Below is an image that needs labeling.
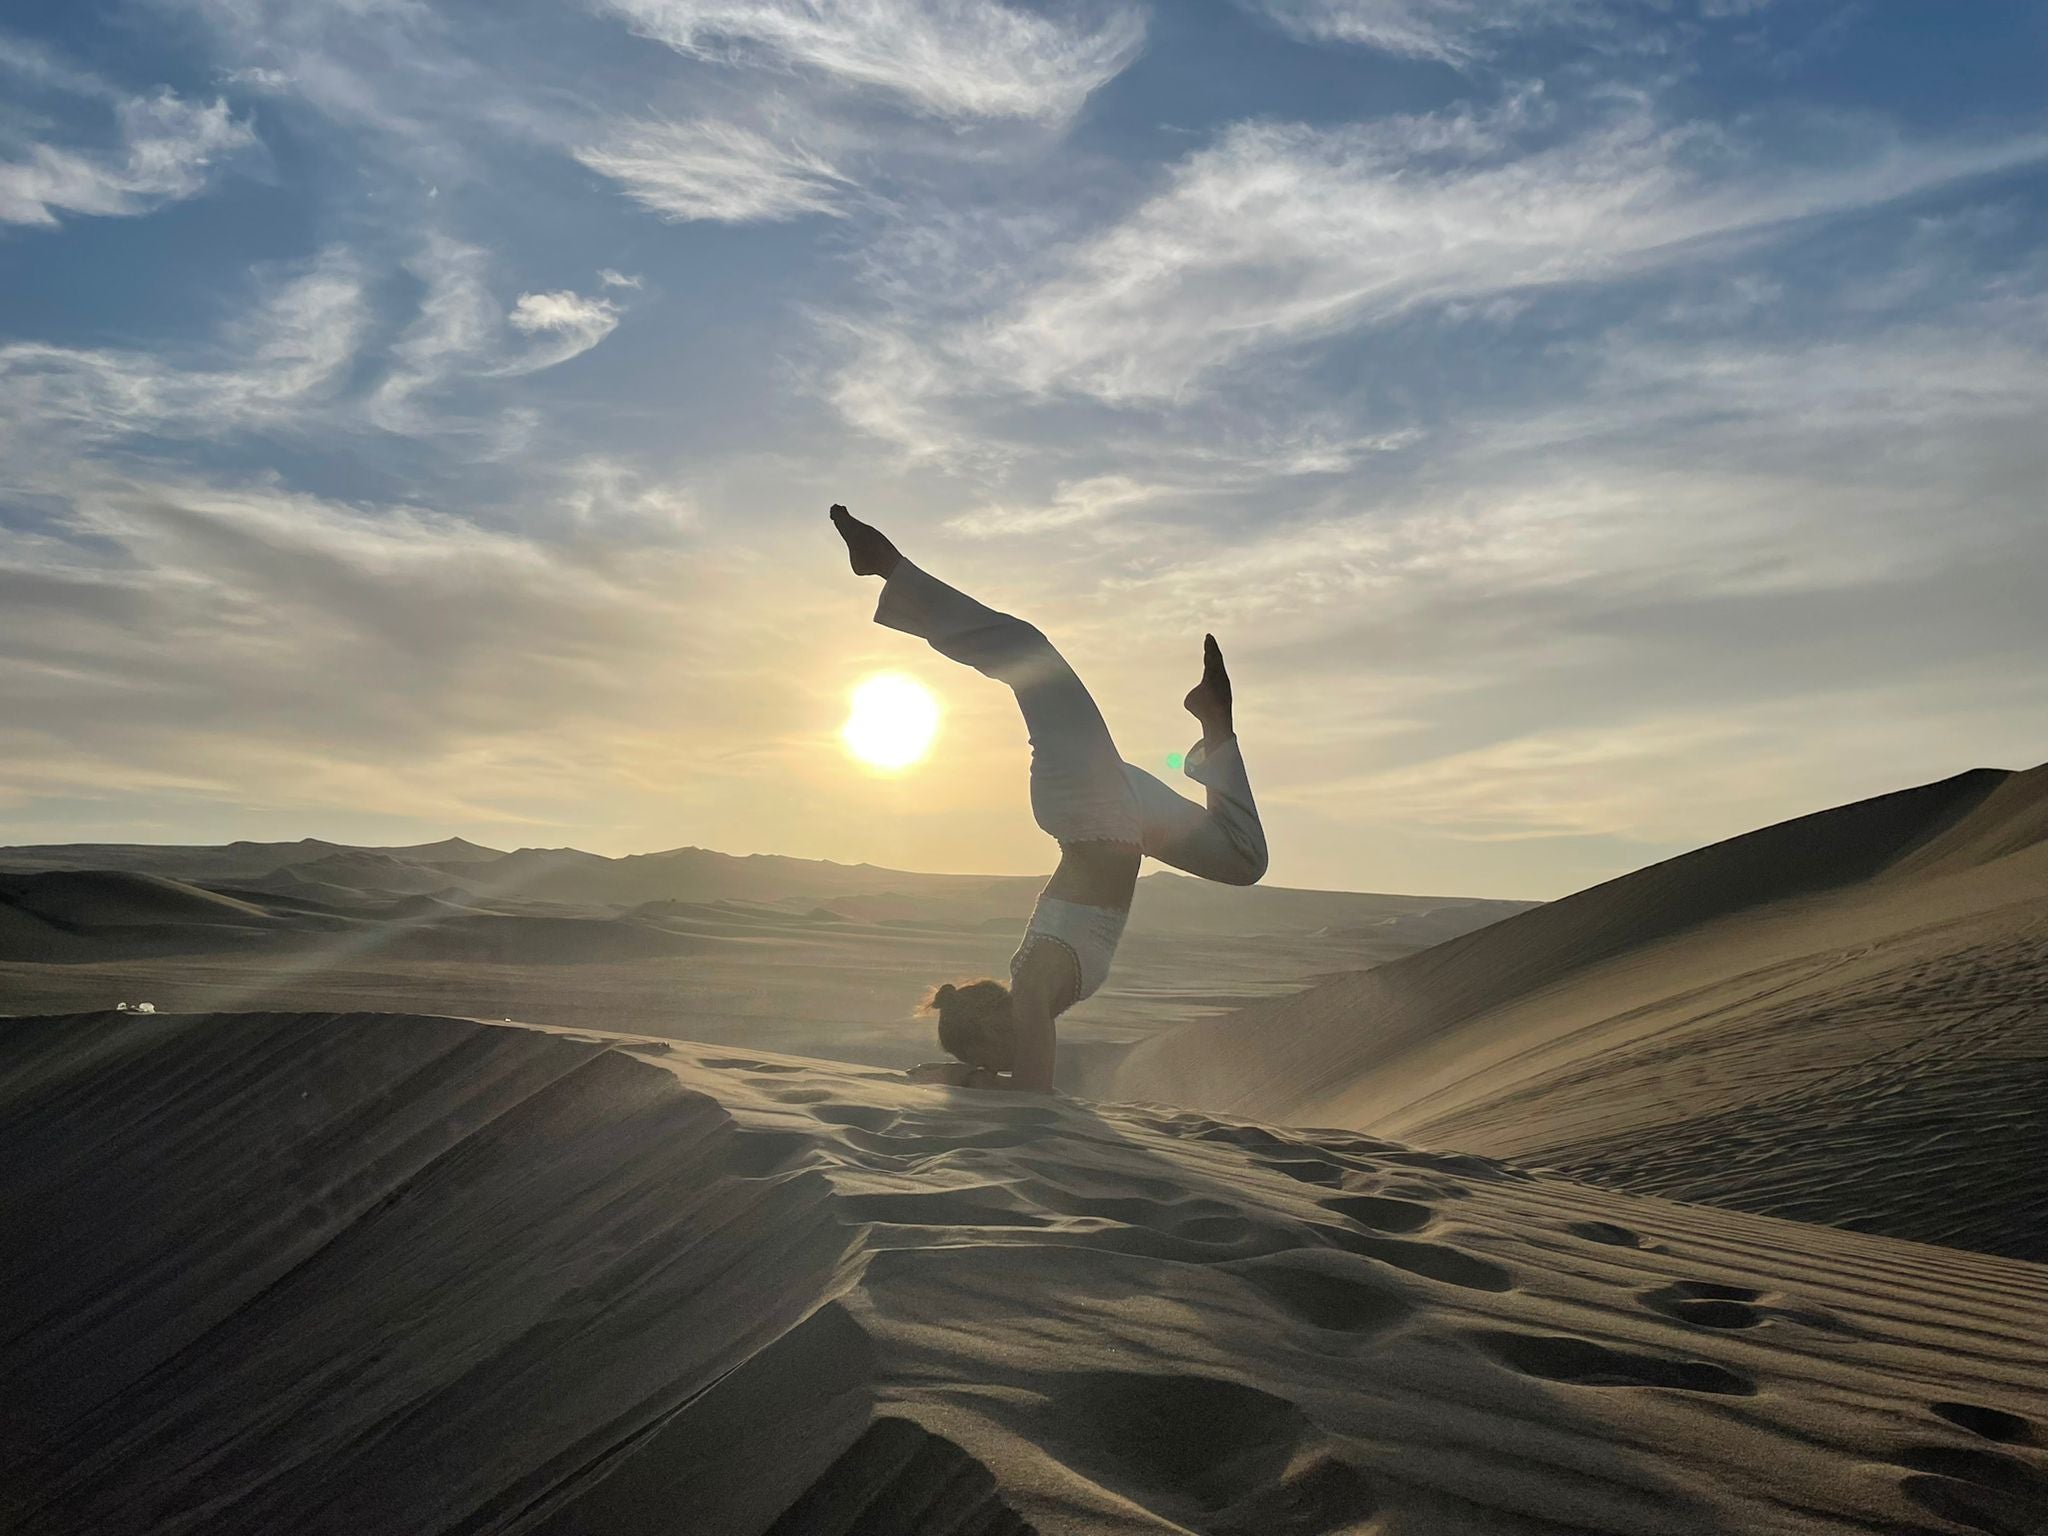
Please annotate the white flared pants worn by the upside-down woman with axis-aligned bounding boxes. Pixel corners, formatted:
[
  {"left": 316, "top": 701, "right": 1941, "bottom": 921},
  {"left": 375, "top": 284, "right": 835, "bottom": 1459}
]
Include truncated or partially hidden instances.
[{"left": 874, "top": 559, "right": 1266, "bottom": 885}]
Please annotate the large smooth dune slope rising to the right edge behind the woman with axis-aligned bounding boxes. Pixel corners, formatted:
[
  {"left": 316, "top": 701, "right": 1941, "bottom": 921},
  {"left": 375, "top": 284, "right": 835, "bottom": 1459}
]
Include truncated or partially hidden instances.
[{"left": 1092, "top": 768, "right": 2048, "bottom": 1260}]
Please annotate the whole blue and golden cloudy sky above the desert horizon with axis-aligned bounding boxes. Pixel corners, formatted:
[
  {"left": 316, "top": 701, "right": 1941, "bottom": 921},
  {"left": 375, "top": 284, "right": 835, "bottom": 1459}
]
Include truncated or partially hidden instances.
[{"left": 0, "top": 0, "right": 2048, "bottom": 897}]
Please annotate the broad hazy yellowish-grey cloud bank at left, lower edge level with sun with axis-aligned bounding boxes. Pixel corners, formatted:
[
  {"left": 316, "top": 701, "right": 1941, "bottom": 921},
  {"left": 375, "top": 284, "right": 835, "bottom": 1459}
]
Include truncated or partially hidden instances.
[{"left": 0, "top": 465, "right": 696, "bottom": 799}]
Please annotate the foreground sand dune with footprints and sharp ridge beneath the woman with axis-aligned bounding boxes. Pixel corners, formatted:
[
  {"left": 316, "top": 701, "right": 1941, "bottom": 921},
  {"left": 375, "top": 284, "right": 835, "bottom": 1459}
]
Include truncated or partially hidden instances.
[{"left": 0, "top": 1016, "right": 2048, "bottom": 1536}]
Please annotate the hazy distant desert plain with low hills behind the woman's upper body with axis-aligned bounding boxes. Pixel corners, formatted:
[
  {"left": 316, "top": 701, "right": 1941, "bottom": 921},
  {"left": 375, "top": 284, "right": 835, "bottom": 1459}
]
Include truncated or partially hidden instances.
[{"left": 0, "top": 838, "right": 1526, "bottom": 1081}]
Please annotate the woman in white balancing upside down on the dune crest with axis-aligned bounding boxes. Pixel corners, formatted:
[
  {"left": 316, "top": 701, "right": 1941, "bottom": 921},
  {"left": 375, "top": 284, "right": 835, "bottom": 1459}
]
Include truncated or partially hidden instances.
[{"left": 831, "top": 506, "right": 1266, "bottom": 1094}]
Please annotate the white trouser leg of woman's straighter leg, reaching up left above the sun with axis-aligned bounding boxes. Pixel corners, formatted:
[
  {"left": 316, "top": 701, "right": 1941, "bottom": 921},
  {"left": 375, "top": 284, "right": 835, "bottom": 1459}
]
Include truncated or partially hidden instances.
[{"left": 874, "top": 559, "right": 1141, "bottom": 848}]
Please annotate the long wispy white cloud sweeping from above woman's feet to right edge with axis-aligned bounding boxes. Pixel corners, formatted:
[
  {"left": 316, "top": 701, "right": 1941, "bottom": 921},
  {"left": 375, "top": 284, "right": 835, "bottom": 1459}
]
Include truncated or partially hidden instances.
[{"left": 836, "top": 96, "right": 2048, "bottom": 453}]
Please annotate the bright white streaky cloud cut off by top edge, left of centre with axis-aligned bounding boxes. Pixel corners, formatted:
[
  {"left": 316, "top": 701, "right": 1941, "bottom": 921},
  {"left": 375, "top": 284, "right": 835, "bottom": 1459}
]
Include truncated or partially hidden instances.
[{"left": 602, "top": 0, "right": 1145, "bottom": 121}]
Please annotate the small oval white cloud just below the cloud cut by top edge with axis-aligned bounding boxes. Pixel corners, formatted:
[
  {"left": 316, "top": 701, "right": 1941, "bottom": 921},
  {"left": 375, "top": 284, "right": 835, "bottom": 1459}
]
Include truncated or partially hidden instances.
[{"left": 575, "top": 121, "right": 848, "bottom": 223}]
